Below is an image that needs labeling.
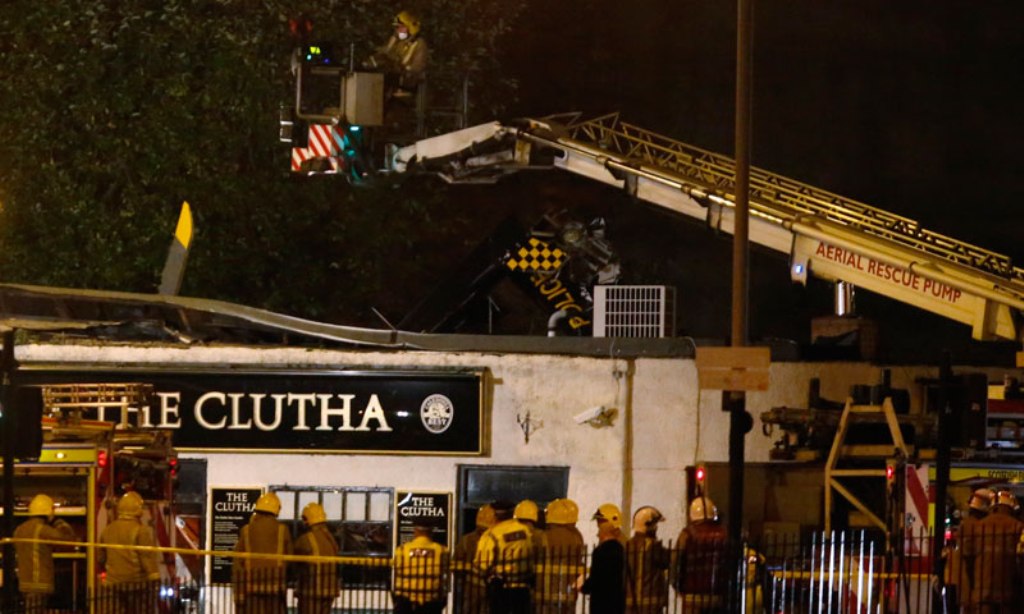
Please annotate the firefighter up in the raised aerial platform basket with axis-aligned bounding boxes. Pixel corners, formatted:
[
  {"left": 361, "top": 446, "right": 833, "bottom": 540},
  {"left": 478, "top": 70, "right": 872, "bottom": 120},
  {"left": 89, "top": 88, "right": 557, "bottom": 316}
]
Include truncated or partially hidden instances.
[{"left": 367, "top": 10, "right": 427, "bottom": 98}]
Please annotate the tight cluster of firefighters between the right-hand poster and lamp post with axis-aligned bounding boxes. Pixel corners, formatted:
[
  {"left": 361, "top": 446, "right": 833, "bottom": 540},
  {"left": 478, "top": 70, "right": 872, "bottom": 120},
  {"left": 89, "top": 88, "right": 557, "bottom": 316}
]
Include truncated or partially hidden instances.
[{"left": 454, "top": 497, "right": 741, "bottom": 614}]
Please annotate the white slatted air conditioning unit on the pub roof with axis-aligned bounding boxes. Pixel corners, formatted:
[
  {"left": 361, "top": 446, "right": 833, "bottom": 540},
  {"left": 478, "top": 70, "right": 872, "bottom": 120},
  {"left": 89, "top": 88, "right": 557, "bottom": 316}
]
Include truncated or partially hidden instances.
[{"left": 594, "top": 286, "right": 676, "bottom": 338}]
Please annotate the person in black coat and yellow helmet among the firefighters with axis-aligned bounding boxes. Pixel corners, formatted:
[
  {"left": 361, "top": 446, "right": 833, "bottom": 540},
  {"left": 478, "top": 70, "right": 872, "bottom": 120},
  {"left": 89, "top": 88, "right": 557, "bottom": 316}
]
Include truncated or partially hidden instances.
[{"left": 577, "top": 503, "right": 626, "bottom": 614}]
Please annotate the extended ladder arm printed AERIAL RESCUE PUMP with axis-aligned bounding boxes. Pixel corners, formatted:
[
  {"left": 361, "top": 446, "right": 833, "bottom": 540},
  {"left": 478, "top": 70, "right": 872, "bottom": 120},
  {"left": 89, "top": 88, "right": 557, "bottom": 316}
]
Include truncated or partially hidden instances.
[{"left": 389, "top": 114, "right": 1024, "bottom": 365}]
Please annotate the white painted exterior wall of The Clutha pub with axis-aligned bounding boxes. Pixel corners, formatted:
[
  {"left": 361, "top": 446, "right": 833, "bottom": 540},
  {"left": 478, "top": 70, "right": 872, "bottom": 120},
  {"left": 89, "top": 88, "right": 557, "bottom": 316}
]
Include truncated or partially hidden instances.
[{"left": 15, "top": 345, "right": 1021, "bottom": 541}]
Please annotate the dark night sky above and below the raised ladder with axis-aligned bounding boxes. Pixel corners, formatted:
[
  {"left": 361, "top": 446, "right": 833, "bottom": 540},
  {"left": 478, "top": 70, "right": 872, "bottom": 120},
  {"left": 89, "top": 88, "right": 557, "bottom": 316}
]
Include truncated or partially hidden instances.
[{"left": 481, "top": 0, "right": 1024, "bottom": 359}]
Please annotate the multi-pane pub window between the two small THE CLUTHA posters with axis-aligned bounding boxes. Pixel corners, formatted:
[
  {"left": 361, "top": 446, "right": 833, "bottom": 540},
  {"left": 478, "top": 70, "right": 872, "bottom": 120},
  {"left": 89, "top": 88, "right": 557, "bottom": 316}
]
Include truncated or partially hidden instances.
[{"left": 270, "top": 485, "right": 394, "bottom": 588}]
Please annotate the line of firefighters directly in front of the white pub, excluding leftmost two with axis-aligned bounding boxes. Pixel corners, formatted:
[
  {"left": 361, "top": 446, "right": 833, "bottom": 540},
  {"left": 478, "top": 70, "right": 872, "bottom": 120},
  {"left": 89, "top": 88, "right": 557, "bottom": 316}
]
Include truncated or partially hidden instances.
[{"left": 225, "top": 492, "right": 727, "bottom": 614}]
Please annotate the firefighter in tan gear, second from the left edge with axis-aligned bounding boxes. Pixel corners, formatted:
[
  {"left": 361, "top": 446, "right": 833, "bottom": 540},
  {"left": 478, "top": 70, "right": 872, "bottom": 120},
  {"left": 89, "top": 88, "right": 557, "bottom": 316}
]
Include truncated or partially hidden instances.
[{"left": 98, "top": 491, "right": 160, "bottom": 614}]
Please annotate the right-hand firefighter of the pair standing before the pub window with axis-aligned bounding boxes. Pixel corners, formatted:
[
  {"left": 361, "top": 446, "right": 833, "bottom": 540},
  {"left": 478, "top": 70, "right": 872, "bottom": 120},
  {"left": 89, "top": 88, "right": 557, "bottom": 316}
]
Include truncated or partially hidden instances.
[{"left": 295, "top": 502, "right": 338, "bottom": 614}]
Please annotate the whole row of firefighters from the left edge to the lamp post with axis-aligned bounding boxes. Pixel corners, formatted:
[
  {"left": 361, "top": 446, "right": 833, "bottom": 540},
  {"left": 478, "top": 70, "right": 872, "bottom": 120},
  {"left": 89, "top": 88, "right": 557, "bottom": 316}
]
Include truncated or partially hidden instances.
[{"left": 14, "top": 492, "right": 726, "bottom": 614}]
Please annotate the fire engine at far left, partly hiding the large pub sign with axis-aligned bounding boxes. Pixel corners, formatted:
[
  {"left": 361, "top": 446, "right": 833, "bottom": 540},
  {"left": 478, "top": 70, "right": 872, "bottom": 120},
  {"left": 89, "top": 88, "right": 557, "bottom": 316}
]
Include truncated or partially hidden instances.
[{"left": 2, "top": 383, "right": 180, "bottom": 611}]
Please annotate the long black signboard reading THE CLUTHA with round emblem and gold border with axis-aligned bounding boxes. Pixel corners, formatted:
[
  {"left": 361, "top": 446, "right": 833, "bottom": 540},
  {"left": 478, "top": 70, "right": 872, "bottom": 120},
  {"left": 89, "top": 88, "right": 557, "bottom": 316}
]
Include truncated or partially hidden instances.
[{"left": 17, "top": 365, "right": 483, "bottom": 455}]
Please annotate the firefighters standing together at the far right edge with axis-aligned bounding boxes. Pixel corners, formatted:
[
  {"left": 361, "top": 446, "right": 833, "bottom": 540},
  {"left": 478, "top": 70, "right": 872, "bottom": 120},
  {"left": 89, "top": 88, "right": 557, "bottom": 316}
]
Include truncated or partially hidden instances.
[{"left": 943, "top": 488, "right": 1024, "bottom": 614}]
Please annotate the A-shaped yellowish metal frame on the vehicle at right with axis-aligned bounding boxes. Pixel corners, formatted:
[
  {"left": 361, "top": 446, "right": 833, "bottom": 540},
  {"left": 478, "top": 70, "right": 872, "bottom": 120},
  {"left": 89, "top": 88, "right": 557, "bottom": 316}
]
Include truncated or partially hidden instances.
[{"left": 824, "top": 398, "right": 910, "bottom": 534}]
